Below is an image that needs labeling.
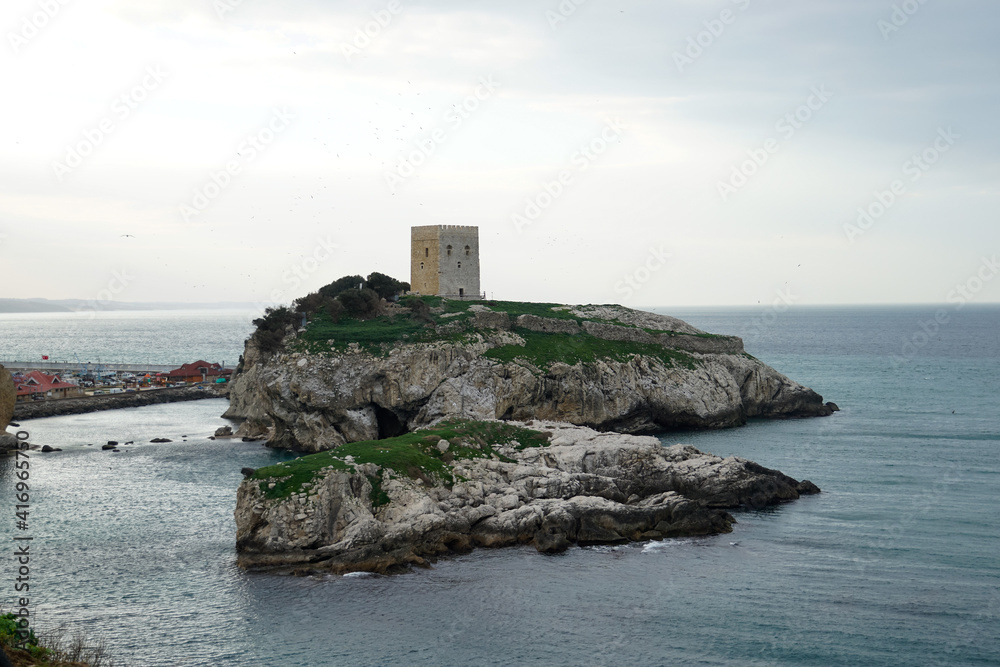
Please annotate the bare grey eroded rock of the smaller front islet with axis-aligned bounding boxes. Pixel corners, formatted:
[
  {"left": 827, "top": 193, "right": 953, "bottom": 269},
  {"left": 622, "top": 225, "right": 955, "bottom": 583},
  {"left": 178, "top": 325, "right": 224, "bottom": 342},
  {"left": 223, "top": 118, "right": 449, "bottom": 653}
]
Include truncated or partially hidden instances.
[{"left": 236, "top": 422, "right": 819, "bottom": 573}]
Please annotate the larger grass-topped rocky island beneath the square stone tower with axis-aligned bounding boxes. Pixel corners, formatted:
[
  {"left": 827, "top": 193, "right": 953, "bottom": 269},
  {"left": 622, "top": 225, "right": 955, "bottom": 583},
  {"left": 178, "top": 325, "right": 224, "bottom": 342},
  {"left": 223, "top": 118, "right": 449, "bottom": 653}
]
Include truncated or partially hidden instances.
[{"left": 224, "top": 297, "right": 835, "bottom": 452}]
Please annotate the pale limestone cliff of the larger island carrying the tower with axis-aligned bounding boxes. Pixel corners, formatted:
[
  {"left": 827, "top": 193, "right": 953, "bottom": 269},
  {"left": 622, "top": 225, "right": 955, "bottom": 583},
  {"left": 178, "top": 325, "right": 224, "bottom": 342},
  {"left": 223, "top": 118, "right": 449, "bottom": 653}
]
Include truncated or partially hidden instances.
[{"left": 225, "top": 306, "right": 830, "bottom": 452}]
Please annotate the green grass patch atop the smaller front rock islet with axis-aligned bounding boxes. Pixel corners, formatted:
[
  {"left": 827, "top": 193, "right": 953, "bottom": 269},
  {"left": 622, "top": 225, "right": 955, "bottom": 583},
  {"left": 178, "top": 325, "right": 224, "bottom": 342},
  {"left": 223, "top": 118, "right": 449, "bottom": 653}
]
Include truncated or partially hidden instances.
[{"left": 251, "top": 419, "right": 548, "bottom": 500}]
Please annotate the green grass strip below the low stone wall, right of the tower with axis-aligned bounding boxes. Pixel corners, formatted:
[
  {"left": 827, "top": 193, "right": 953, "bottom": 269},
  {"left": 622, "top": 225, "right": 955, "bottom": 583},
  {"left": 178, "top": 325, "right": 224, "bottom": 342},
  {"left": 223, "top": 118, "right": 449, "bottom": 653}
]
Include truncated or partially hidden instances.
[{"left": 483, "top": 329, "right": 698, "bottom": 370}]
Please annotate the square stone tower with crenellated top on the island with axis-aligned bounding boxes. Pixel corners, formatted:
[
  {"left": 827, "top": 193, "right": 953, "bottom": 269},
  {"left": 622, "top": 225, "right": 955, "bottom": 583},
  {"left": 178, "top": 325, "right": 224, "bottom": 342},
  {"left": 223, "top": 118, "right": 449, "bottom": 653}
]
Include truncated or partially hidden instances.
[{"left": 410, "top": 225, "right": 481, "bottom": 299}]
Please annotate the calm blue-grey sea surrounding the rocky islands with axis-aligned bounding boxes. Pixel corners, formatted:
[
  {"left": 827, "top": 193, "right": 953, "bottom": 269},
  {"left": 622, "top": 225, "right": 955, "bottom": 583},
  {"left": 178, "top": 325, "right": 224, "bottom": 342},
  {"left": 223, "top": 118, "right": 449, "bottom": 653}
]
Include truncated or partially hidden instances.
[{"left": 0, "top": 306, "right": 1000, "bottom": 667}]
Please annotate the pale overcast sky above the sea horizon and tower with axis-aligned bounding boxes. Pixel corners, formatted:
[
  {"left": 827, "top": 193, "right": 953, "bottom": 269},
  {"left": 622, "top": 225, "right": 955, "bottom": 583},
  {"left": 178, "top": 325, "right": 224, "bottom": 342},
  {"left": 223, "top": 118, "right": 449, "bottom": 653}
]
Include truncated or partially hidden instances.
[{"left": 0, "top": 0, "right": 1000, "bottom": 307}]
